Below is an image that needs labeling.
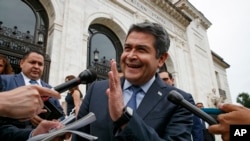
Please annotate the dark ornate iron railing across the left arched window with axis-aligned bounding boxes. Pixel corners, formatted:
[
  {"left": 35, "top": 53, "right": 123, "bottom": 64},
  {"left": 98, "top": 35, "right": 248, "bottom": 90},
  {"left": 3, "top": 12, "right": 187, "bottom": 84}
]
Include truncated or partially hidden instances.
[{"left": 0, "top": 21, "right": 51, "bottom": 82}]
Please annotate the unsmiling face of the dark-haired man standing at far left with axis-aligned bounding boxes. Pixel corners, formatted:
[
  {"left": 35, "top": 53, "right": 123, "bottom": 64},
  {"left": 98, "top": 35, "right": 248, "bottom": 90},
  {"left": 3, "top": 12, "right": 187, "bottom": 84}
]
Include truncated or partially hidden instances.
[{"left": 20, "top": 52, "right": 44, "bottom": 80}]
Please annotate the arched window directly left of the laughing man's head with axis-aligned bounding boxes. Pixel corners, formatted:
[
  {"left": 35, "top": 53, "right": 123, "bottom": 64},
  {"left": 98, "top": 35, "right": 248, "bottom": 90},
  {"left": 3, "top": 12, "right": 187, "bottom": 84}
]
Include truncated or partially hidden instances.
[{"left": 88, "top": 24, "right": 123, "bottom": 80}]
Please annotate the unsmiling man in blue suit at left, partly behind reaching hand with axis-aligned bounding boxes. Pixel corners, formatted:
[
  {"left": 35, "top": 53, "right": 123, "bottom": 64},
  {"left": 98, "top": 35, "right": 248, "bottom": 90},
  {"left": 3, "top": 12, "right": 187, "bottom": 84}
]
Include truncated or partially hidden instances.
[{"left": 0, "top": 51, "right": 63, "bottom": 141}]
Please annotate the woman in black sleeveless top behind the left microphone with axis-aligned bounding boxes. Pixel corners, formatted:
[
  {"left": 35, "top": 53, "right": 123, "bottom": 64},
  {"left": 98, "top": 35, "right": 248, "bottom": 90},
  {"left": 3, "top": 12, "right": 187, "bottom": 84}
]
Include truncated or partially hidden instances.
[{"left": 65, "top": 75, "right": 82, "bottom": 115}]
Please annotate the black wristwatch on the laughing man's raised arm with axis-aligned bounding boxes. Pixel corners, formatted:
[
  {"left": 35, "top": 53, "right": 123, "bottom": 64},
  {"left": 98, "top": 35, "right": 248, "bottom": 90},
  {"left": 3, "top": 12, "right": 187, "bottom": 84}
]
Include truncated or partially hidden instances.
[{"left": 114, "top": 107, "right": 133, "bottom": 130}]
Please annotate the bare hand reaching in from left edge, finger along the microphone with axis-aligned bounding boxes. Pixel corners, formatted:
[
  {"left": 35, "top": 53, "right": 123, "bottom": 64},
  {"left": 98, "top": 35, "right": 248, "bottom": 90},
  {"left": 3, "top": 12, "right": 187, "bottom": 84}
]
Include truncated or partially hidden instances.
[{"left": 0, "top": 85, "right": 60, "bottom": 119}]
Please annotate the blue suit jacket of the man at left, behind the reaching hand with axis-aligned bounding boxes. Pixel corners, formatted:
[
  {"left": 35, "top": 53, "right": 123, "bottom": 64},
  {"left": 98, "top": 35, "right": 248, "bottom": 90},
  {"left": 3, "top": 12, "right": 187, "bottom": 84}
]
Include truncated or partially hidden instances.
[{"left": 0, "top": 73, "right": 63, "bottom": 141}]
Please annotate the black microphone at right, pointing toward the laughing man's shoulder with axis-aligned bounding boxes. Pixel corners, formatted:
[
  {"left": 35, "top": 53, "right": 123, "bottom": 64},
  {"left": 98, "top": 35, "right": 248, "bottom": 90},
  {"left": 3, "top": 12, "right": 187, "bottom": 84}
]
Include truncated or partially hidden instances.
[{"left": 168, "top": 90, "right": 218, "bottom": 125}]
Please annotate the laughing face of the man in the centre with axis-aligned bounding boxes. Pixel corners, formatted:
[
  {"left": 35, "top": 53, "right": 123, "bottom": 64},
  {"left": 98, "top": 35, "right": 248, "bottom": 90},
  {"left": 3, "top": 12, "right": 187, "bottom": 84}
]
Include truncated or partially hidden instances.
[{"left": 120, "top": 31, "right": 167, "bottom": 85}]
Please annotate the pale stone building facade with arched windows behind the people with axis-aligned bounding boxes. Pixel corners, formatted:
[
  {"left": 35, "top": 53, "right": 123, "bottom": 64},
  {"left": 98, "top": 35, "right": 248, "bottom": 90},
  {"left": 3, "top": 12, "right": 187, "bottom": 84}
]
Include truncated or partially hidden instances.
[{"left": 0, "top": 0, "right": 231, "bottom": 107}]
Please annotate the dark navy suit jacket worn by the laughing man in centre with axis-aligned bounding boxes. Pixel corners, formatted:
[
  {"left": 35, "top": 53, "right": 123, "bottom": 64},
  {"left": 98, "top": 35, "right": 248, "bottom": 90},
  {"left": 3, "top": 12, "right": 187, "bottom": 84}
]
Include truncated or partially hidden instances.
[{"left": 73, "top": 74, "right": 194, "bottom": 141}]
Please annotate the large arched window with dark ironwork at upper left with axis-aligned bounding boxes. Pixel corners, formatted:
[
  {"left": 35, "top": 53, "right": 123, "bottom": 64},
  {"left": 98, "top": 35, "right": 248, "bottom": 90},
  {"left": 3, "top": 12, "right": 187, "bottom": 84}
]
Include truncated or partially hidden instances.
[{"left": 0, "top": 0, "right": 50, "bottom": 81}]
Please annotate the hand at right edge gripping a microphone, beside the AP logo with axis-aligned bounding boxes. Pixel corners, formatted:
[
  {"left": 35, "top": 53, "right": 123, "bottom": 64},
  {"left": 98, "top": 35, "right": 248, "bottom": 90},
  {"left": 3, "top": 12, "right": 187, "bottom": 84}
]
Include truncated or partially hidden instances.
[{"left": 208, "top": 104, "right": 250, "bottom": 141}]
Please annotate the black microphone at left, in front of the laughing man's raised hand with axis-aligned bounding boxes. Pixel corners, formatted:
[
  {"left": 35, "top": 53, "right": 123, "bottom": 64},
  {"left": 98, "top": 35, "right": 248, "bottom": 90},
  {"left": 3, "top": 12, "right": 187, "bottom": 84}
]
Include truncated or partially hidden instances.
[{"left": 52, "top": 69, "right": 97, "bottom": 93}]
